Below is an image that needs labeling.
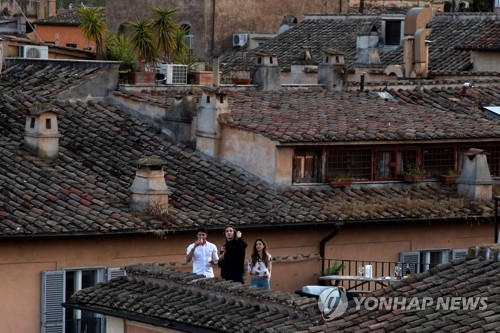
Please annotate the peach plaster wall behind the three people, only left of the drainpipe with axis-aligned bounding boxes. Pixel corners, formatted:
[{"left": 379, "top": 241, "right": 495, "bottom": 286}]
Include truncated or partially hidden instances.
[{"left": 0, "top": 230, "right": 320, "bottom": 332}]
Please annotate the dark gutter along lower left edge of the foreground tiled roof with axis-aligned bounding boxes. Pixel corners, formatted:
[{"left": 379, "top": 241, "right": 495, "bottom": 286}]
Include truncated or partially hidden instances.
[{"left": 61, "top": 303, "right": 220, "bottom": 333}]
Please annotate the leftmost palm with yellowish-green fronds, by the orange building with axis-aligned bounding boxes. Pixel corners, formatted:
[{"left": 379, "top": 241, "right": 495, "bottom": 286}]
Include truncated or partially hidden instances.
[{"left": 77, "top": 7, "right": 108, "bottom": 59}]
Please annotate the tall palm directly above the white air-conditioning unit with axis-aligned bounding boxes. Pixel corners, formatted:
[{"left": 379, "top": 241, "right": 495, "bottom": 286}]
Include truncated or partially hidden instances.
[{"left": 151, "top": 7, "right": 184, "bottom": 63}]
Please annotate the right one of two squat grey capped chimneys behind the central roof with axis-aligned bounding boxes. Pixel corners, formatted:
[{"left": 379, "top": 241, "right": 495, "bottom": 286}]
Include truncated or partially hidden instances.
[{"left": 318, "top": 49, "right": 347, "bottom": 91}]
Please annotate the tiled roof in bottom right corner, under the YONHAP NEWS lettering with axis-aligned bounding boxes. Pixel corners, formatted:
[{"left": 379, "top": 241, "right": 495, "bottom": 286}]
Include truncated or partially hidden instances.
[{"left": 301, "top": 244, "right": 500, "bottom": 333}]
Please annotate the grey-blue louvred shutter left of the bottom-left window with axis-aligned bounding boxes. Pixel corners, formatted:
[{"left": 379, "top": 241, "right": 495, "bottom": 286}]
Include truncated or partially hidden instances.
[{"left": 41, "top": 271, "right": 66, "bottom": 333}]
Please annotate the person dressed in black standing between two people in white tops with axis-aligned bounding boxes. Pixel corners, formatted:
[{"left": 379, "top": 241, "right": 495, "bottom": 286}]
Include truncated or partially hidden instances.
[{"left": 218, "top": 225, "right": 247, "bottom": 283}]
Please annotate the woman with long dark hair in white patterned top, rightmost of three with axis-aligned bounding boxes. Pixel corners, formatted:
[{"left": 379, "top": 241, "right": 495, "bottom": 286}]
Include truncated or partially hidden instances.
[{"left": 248, "top": 238, "right": 273, "bottom": 289}]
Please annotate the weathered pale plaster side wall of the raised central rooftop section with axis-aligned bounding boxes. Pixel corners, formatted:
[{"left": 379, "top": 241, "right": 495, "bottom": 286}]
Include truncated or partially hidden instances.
[{"left": 220, "top": 127, "right": 278, "bottom": 184}]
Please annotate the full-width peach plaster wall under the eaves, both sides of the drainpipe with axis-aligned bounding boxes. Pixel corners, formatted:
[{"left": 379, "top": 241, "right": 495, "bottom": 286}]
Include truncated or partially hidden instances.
[{"left": 0, "top": 220, "right": 493, "bottom": 332}]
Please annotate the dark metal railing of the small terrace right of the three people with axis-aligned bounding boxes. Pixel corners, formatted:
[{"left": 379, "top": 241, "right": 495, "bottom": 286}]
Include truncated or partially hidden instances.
[{"left": 322, "top": 259, "right": 437, "bottom": 292}]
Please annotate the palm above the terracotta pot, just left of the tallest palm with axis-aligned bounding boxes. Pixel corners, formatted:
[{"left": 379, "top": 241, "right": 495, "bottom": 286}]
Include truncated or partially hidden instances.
[{"left": 125, "top": 20, "right": 158, "bottom": 71}]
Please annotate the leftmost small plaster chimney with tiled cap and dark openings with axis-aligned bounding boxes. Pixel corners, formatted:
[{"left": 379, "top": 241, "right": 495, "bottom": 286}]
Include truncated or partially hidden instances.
[{"left": 24, "top": 103, "right": 62, "bottom": 160}]
